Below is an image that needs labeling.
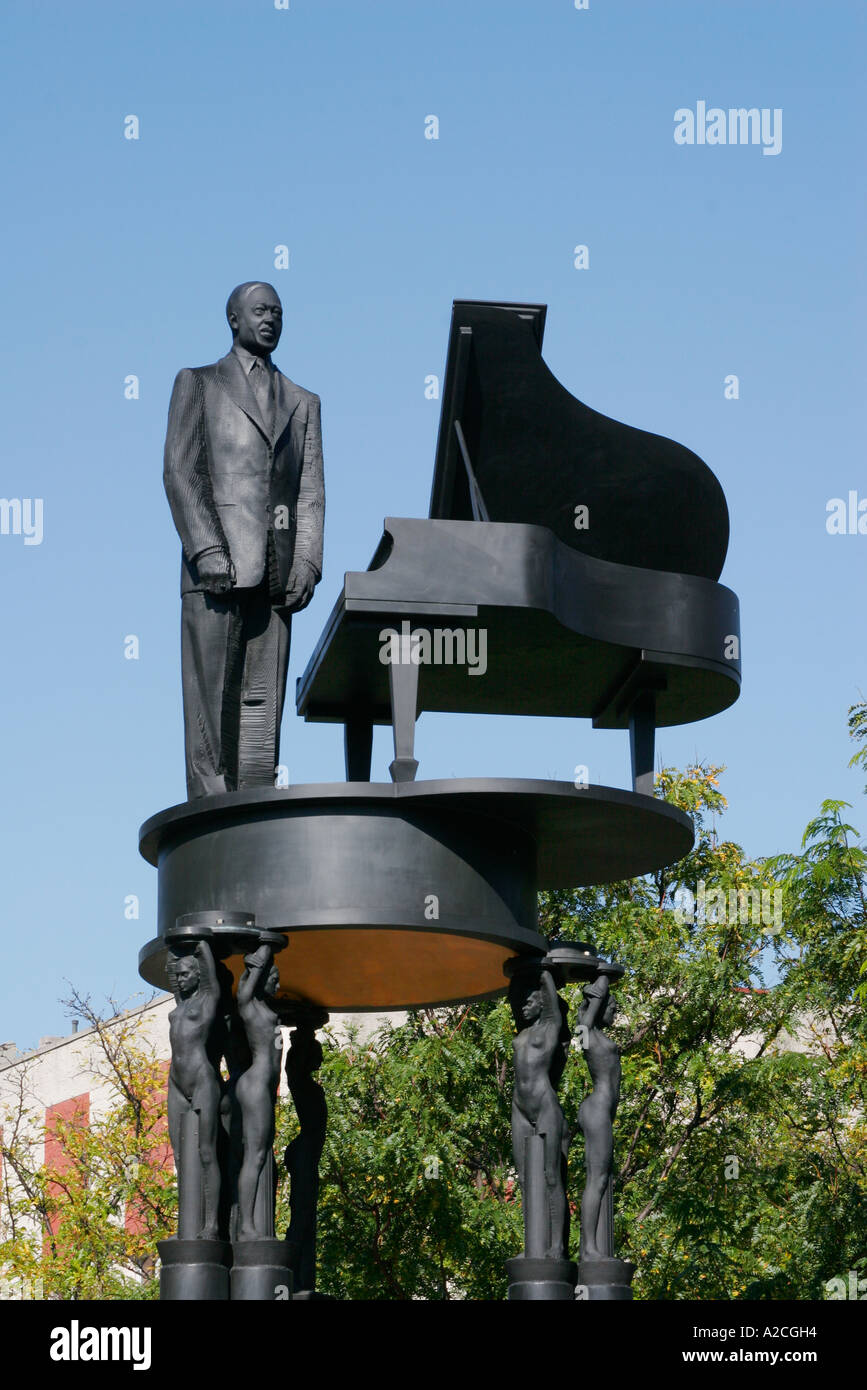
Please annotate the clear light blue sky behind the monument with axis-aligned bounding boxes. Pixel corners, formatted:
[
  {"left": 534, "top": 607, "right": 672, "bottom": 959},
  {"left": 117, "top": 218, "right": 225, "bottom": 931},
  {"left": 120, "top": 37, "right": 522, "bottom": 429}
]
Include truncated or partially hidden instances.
[{"left": 0, "top": 0, "right": 867, "bottom": 1045}]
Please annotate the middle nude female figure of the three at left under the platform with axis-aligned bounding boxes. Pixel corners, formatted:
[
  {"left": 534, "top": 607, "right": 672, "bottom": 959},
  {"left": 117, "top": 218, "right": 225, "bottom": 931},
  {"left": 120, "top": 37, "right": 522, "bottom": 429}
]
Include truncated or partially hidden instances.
[{"left": 235, "top": 942, "right": 282, "bottom": 1240}]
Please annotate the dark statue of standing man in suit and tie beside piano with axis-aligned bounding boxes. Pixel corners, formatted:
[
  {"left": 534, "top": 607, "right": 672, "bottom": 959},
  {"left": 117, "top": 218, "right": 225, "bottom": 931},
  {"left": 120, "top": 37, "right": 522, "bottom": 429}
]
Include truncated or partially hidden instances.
[{"left": 164, "top": 281, "right": 325, "bottom": 801}]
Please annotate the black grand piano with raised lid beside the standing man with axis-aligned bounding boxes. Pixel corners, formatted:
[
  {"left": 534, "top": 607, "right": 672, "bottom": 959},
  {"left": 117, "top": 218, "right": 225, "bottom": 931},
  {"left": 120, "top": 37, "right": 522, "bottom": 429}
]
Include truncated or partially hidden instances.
[{"left": 296, "top": 300, "right": 741, "bottom": 795}]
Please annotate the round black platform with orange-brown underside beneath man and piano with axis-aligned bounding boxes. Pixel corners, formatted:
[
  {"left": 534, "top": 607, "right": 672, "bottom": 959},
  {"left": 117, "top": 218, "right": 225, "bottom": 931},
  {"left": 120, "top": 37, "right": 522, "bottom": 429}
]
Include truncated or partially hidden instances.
[{"left": 139, "top": 778, "right": 693, "bottom": 1012}]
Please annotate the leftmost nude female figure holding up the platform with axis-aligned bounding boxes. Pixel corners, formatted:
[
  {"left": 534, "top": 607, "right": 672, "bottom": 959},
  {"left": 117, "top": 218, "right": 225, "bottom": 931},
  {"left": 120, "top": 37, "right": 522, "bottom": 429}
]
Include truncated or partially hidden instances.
[{"left": 167, "top": 941, "right": 221, "bottom": 1240}]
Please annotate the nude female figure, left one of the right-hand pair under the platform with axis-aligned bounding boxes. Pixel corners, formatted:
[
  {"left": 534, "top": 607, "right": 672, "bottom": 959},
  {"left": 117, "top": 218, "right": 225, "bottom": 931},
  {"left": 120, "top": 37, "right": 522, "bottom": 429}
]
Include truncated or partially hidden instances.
[{"left": 509, "top": 970, "right": 570, "bottom": 1259}]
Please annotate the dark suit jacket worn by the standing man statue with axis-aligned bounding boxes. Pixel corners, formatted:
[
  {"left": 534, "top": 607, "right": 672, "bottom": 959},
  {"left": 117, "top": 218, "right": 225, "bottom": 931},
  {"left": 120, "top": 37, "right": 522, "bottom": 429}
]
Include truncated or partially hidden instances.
[{"left": 163, "top": 352, "right": 325, "bottom": 594}]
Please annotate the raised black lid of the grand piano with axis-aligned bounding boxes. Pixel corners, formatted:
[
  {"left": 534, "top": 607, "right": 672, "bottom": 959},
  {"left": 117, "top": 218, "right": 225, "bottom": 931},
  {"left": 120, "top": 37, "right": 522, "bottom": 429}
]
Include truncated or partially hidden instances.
[{"left": 431, "top": 299, "right": 728, "bottom": 580}]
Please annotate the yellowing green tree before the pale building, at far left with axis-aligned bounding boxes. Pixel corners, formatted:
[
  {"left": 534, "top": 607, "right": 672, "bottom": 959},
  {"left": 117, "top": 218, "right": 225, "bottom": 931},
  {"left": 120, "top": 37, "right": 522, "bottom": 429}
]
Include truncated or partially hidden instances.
[{"left": 0, "top": 994, "right": 176, "bottom": 1300}]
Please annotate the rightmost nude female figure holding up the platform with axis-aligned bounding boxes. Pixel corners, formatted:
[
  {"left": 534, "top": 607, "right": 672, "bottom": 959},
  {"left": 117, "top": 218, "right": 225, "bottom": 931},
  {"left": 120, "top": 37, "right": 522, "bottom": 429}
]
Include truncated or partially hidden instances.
[{"left": 578, "top": 974, "right": 621, "bottom": 1259}]
